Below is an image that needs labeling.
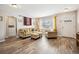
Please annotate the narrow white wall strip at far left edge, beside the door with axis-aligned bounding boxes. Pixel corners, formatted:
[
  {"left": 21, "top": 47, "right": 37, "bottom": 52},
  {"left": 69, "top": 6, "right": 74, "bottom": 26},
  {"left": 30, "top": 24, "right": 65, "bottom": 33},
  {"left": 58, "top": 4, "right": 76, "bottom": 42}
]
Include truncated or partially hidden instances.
[{"left": 0, "top": 17, "right": 6, "bottom": 42}]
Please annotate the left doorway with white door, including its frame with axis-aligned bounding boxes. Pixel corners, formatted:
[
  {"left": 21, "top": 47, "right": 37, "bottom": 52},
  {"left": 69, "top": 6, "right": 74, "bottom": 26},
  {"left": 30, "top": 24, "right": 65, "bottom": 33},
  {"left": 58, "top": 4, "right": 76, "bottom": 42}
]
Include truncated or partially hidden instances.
[{"left": 6, "top": 16, "right": 16, "bottom": 38}]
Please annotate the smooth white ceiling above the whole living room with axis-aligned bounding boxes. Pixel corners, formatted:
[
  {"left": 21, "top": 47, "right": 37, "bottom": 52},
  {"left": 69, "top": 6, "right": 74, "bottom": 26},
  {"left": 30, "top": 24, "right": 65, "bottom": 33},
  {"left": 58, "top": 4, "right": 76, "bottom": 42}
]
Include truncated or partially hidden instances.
[{"left": 0, "top": 4, "right": 79, "bottom": 17}]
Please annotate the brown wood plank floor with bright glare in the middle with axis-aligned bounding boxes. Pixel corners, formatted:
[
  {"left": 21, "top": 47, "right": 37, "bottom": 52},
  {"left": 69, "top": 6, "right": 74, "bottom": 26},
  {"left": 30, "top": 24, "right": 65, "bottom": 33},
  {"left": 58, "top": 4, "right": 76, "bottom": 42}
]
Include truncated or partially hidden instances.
[{"left": 0, "top": 36, "right": 79, "bottom": 54}]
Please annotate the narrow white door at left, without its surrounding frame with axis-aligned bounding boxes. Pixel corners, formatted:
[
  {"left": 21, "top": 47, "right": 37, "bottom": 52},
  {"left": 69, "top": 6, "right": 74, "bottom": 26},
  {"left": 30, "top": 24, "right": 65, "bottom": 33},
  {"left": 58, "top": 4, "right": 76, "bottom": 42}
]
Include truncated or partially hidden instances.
[{"left": 8, "top": 17, "right": 16, "bottom": 37}]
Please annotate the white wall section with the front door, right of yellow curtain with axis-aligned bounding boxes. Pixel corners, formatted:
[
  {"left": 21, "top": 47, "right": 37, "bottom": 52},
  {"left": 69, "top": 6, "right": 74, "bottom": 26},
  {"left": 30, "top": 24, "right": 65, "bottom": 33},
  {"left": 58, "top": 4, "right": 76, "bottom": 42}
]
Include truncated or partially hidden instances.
[{"left": 57, "top": 11, "right": 77, "bottom": 38}]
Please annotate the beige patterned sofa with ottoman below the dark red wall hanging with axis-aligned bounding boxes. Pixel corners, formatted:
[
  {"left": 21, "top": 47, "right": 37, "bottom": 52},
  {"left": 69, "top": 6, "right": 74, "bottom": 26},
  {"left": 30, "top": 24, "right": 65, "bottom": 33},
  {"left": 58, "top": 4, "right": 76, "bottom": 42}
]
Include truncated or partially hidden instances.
[{"left": 18, "top": 28, "right": 42, "bottom": 39}]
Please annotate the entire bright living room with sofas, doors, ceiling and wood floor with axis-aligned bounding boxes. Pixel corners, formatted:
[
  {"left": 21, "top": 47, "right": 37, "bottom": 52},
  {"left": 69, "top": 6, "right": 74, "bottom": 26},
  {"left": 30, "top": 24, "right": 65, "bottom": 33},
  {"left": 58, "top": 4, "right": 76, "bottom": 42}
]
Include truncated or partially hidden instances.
[{"left": 0, "top": 4, "right": 79, "bottom": 54}]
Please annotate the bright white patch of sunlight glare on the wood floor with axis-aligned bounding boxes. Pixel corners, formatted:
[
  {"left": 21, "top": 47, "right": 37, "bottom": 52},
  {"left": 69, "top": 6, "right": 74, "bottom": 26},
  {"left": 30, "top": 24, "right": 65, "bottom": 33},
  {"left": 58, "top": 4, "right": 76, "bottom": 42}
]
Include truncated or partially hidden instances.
[{"left": 32, "top": 36, "right": 58, "bottom": 54}]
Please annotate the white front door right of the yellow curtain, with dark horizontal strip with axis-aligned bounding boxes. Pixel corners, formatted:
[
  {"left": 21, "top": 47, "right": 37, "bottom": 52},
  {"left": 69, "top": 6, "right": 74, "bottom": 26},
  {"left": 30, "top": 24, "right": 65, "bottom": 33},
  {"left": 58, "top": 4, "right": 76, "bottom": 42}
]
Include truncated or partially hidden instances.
[{"left": 62, "top": 13, "right": 76, "bottom": 38}]
